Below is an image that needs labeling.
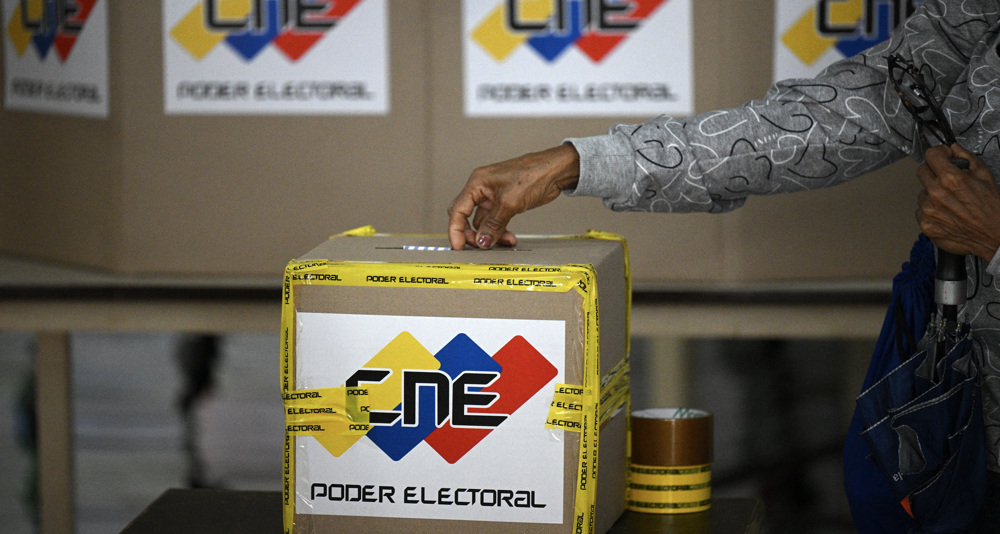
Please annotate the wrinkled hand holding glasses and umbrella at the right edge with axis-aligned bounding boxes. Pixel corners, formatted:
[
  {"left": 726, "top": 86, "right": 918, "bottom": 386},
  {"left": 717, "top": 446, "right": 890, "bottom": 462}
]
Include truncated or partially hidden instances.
[{"left": 916, "top": 144, "right": 1000, "bottom": 261}]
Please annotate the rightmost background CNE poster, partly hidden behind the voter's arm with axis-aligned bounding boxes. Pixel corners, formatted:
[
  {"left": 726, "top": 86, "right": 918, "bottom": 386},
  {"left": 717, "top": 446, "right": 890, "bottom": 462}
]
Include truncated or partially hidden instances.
[{"left": 774, "top": 0, "right": 921, "bottom": 81}]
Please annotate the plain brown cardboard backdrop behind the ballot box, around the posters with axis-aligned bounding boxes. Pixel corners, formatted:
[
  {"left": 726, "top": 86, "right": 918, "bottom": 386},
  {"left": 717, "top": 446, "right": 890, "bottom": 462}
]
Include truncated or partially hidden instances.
[{"left": 0, "top": 0, "right": 918, "bottom": 284}]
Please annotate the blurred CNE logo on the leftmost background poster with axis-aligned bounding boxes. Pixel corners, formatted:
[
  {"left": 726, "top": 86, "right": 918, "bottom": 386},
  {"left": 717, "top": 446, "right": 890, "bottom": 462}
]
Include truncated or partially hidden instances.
[{"left": 7, "top": 0, "right": 97, "bottom": 63}]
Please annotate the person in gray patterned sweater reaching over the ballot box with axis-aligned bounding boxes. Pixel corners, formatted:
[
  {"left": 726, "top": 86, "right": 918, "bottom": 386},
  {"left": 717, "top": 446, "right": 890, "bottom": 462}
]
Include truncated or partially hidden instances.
[{"left": 448, "top": 0, "right": 1000, "bottom": 529}]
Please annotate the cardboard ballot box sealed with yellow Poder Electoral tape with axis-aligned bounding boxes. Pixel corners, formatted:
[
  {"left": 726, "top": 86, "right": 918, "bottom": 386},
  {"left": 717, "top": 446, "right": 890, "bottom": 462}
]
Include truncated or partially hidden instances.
[{"left": 283, "top": 236, "right": 628, "bottom": 533}]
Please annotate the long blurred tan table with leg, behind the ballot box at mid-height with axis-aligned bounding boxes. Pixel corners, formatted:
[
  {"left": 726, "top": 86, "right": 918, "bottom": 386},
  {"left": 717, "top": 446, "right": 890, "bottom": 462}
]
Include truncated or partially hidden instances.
[{"left": 0, "top": 255, "right": 891, "bottom": 534}]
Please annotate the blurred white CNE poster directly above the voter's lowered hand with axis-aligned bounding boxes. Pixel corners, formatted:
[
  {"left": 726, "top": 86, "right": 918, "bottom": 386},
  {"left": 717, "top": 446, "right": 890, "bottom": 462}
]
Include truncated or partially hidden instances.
[{"left": 462, "top": 0, "right": 694, "bottom": 117}]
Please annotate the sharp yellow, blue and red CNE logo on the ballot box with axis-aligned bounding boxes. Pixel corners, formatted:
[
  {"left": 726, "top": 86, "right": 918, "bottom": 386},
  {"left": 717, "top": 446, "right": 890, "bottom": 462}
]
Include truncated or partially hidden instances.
[{"left": 316, "top": 332, "right": 557, "bottom": 463}]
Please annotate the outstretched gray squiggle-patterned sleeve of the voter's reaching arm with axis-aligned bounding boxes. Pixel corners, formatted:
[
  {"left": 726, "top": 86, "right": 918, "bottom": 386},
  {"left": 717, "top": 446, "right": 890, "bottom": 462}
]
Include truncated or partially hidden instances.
[{"left": 566, "top": 0, "right": 998, "bottom": 213}]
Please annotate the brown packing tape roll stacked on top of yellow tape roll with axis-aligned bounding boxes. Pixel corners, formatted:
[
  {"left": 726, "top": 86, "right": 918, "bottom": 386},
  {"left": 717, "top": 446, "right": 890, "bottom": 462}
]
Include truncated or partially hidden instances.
[{"left": 632, "top": 408, "right": 712, "bottom": 467}]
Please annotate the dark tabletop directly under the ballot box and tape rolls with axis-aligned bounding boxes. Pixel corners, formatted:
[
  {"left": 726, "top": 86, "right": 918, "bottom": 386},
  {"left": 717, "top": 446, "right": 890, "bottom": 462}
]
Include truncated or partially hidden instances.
[{"left": 122, "top": 489, "right": 764, "bottom": 534}]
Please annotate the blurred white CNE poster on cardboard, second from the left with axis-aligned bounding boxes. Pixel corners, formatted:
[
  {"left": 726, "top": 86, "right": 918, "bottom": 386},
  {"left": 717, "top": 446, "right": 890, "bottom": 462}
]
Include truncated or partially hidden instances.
[{"left": 162, "top": 0, "right": 389, "bottom": 115}]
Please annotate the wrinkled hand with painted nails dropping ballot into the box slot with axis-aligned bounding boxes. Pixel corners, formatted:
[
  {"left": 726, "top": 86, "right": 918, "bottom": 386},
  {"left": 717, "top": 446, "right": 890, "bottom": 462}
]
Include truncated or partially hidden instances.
[{"left": 448, "top": 145, "right": 580, "bottom": 250}]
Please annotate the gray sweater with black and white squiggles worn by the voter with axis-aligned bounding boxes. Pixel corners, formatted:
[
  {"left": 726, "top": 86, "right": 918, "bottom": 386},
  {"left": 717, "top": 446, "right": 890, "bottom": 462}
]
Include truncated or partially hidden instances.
[{"left": 567, "top": 0, "right": 1000, "bottom": 478}]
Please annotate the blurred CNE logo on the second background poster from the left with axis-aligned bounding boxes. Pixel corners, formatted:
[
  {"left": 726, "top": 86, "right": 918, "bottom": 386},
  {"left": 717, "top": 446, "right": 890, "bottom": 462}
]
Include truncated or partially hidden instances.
[{"left": 170, "top": 0, "right": 361, "bottom": 63}]
